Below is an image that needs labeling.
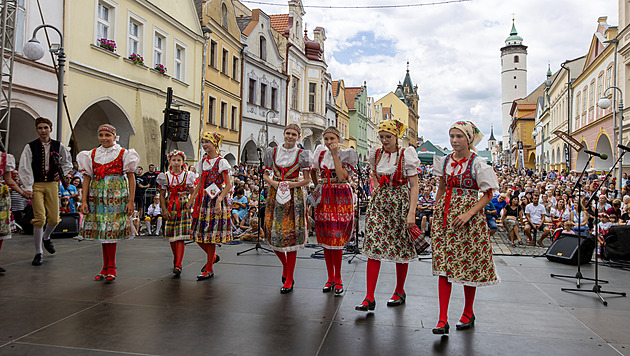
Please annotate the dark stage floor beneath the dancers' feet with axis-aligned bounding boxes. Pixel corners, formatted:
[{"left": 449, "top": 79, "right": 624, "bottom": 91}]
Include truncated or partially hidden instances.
[{"left": 0, "top": 235, "right": 630, "bottom": 356}]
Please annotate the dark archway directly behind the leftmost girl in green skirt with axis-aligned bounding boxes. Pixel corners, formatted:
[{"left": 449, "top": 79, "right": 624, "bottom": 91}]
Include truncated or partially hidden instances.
[{"left": 70, "top": 99, "right": 135, "bottom": 157}]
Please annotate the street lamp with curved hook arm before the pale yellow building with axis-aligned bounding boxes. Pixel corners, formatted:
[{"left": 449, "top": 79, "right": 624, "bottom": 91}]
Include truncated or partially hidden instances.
[{"left": 23, "top": 24, "right": 66, "bottom": 141}]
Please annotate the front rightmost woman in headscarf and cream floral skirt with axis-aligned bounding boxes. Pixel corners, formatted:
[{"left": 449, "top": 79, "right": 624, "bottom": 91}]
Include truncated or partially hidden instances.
[{"left": 432, "top": 121, "right": 499, "bottom": 334}]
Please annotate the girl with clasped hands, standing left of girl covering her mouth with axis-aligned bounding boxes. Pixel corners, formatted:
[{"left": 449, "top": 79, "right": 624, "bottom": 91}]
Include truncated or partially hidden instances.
[{"left": 263, "top": 124, "right": 311, "bottom": 294}]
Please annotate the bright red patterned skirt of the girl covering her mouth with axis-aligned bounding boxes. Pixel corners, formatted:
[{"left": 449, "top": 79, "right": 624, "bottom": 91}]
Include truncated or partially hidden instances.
[{"left": 315, "top": 183, "right": 354, "bottom": 250}]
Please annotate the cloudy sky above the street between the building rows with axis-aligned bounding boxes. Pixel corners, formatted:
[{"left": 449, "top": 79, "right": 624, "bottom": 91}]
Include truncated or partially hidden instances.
[{"left": 243, "top": 0, "right": 619, "bottom": 149}]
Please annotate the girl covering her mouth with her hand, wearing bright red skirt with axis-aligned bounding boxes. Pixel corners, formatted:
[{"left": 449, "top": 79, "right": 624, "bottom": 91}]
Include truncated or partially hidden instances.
[{"left": 311, "top": 126, "right": 358, "bottom": 294}]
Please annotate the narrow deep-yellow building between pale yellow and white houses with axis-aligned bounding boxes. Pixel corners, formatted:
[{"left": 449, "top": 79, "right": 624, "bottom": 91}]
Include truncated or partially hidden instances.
[{"left": 196, "top": 0, "right": 243, "bottom": 165}]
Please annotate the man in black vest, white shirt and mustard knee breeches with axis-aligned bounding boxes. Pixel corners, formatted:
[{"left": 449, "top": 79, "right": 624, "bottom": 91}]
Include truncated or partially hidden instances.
[{"left": 19, "top": 117, "right": 72, "bottom": 266}]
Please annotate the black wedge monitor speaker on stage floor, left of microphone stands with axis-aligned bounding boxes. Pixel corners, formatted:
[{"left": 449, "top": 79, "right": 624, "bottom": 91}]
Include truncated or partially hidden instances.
[{"left": 545, "top": 234, "right": 595, "bottom": 266}]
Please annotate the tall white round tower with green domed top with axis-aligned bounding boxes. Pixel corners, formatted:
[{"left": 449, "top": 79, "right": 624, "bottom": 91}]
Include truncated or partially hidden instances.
[{"left": 501, "top": 19, "right": 527, "bottom": 150}]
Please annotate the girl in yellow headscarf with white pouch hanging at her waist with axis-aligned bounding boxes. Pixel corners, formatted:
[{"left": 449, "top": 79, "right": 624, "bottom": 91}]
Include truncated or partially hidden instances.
[{"left": 190, "top": 132, "right": 232, "bottom": 280}]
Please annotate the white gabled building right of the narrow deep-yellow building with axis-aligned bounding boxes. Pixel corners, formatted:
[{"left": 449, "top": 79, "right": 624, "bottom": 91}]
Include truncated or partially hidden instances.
[{"left": 236, "top": 9, "right": 287, "bottom": 164}]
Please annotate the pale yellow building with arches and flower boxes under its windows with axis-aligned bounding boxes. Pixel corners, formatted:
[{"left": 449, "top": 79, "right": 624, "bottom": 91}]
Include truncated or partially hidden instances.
[{"left": 63, "top": 0, "right": 203, "bottom": 169}]
